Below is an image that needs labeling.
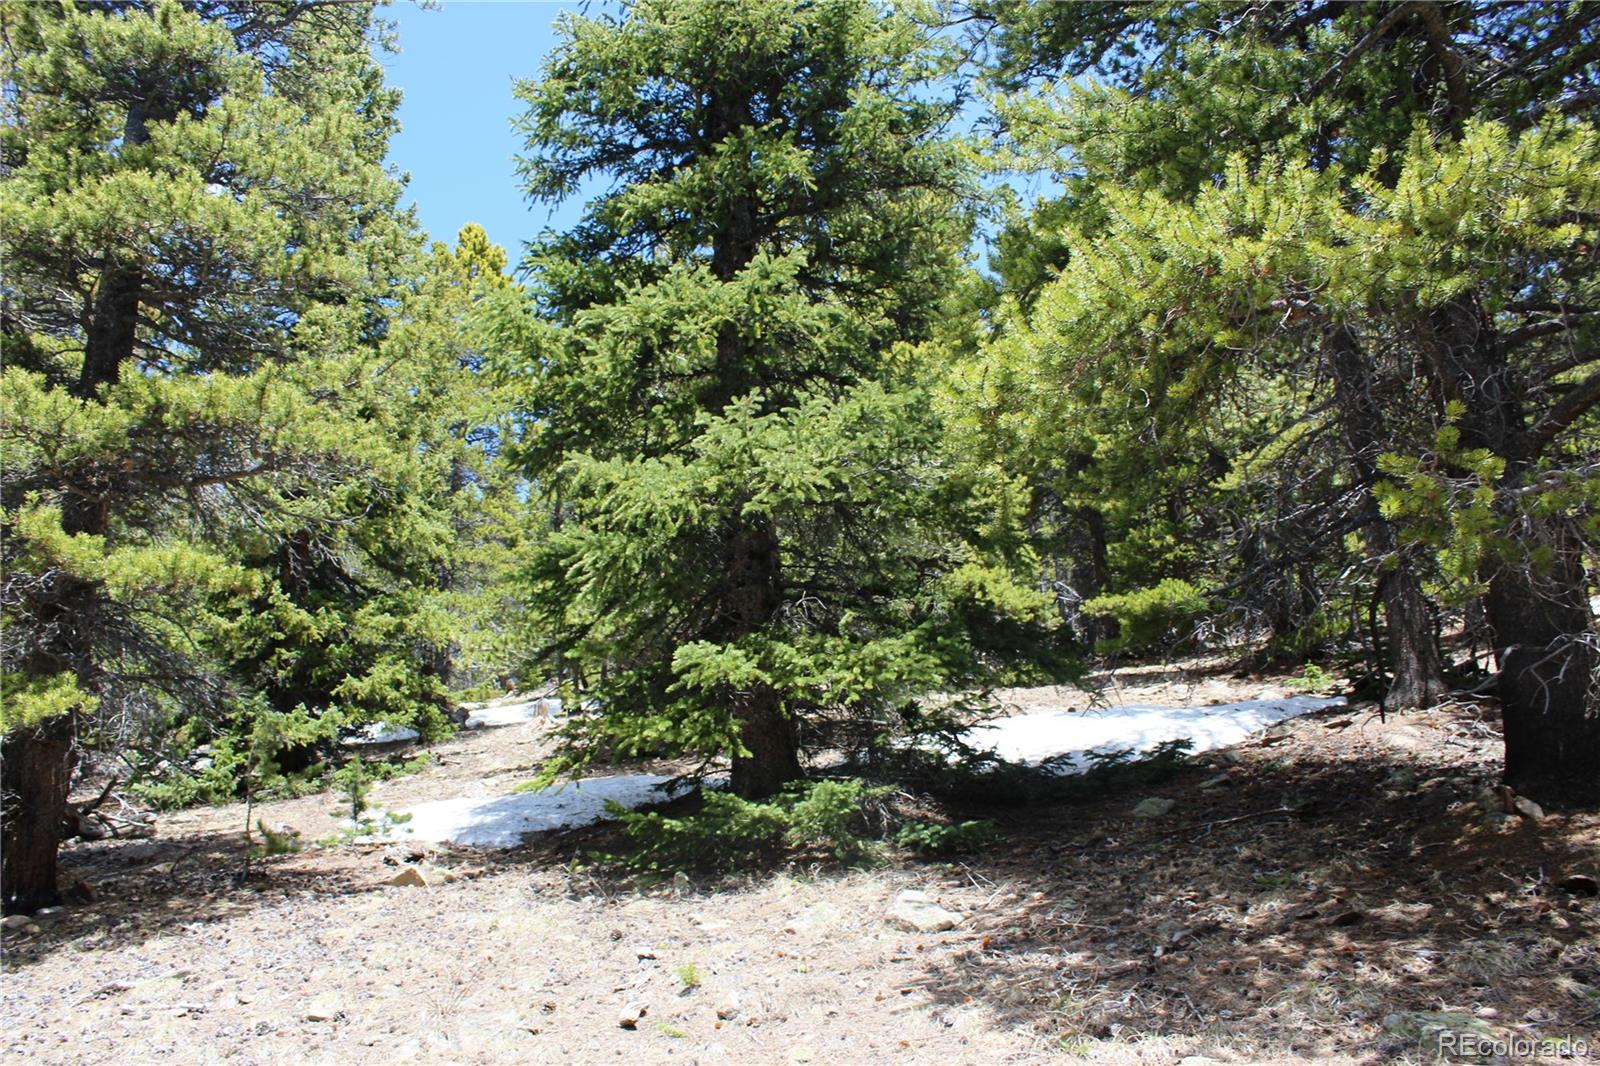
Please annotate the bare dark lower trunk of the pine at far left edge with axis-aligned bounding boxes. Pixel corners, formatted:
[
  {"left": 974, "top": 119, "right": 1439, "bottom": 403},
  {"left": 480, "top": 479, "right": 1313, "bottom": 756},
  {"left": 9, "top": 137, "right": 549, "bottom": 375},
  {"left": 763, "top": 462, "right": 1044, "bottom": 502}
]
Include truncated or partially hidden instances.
[{"left": 0, "top": 714, "right": 74, "bottom": 914}]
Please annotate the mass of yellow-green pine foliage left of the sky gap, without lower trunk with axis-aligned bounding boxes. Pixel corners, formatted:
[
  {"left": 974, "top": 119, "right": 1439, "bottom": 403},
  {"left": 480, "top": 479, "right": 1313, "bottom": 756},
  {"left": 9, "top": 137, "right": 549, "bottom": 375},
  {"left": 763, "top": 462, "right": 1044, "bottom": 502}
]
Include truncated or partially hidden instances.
[{"left": 0, "top": 2, "right": 522, "bottom": 819}]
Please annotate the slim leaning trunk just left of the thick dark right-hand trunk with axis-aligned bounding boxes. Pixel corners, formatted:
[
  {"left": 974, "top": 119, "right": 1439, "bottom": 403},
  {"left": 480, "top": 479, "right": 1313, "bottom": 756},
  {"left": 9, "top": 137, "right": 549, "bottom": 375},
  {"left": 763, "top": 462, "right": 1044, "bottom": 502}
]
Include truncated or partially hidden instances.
[{"left": 1323, "top": 325, "right": 1450, "bottom": 711}]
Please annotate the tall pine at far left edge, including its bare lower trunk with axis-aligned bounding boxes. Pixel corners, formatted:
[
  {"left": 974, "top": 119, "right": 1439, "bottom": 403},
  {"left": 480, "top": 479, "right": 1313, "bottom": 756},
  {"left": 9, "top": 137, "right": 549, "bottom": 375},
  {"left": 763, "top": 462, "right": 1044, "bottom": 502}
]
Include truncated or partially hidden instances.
[{"left": 0, "top": 0, "right": 442, "bottom": 911}]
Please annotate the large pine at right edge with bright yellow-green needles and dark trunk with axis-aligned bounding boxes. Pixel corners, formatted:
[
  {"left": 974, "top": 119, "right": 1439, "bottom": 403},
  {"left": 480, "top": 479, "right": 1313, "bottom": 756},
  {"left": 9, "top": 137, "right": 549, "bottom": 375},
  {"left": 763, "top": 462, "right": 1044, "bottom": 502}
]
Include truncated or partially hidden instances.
[{"left": 960, "top": 3, "right": 1600, "bottom": 795}]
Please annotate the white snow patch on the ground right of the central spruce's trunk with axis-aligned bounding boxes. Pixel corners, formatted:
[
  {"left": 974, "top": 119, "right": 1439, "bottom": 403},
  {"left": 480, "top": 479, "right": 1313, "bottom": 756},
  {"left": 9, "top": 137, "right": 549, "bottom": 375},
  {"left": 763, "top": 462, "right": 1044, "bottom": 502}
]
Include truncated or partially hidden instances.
[{"left": 965, "top": 696, "right": 1344, "bottom": 773}]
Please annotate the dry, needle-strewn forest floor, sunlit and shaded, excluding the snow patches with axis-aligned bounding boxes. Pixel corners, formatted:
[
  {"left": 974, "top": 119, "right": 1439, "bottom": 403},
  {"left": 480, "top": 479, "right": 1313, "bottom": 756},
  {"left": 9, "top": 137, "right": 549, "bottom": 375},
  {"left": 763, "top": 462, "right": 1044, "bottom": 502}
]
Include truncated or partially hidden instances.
[{"left": 0, "top": 663, "right": 1600, "bottom": 1064}]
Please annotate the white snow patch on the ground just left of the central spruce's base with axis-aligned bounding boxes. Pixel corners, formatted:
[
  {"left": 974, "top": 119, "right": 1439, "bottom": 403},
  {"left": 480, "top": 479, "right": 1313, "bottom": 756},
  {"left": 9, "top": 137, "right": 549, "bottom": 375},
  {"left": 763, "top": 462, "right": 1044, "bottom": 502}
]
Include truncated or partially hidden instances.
[{"left": 377, "top": 773, "right": 710, "bottom": 848}]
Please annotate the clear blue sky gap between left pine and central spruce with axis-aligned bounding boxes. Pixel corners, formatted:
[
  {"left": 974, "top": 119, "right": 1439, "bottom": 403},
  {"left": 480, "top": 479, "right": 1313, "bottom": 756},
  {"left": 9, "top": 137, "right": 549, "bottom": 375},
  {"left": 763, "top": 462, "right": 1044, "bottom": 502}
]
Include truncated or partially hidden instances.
[{"left": 382, "top": 0, "right": 581, "bottom": 262}]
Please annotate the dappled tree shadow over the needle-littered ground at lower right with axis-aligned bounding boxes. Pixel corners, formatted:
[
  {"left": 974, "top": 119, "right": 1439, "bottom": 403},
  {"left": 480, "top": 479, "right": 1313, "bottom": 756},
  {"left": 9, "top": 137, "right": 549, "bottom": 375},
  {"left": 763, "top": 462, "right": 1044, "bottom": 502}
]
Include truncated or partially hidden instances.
[{"left": 920, "top": 701, "right": 1600, "bottom": 1060}]
